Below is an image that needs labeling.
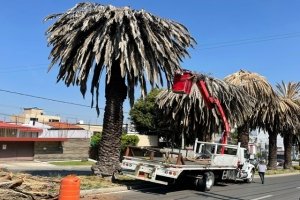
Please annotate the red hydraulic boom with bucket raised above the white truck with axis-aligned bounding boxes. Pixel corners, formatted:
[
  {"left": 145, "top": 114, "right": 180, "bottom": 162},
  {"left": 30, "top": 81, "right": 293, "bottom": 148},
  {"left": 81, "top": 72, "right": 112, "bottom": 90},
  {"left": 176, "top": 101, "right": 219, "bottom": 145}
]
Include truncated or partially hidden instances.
[{"left": 172, "top": 71, "right": 230, "bottom": 154}]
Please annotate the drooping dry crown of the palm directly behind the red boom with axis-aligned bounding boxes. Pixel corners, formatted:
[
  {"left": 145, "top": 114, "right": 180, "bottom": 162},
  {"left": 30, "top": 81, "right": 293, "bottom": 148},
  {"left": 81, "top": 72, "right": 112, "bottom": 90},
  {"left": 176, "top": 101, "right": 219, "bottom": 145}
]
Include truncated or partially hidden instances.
[{"left": 156, "top": 73, "right": 255, "bottom": 142}]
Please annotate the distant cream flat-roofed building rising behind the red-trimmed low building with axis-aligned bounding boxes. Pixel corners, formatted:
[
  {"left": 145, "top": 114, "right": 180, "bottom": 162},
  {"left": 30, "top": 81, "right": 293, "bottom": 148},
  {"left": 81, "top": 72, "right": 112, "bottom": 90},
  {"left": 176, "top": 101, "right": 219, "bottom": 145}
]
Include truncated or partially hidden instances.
[{"left": 11, "top": 107, "right": 60, "bottom": 124}]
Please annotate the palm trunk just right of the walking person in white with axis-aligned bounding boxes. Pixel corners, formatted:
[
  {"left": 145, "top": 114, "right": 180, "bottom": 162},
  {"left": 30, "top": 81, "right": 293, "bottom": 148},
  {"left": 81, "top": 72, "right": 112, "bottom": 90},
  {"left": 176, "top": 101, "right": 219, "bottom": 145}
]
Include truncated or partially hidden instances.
[{"left": 268, "top": 131, "right": 277, "bottom": 169}]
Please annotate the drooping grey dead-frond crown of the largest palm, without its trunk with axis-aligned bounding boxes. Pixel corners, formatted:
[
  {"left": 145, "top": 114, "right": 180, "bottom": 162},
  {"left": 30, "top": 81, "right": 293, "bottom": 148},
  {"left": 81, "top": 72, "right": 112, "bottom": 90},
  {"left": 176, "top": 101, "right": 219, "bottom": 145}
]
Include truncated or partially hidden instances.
[{"left": 45, "top": 3, "right": 195, "bottom": 111}]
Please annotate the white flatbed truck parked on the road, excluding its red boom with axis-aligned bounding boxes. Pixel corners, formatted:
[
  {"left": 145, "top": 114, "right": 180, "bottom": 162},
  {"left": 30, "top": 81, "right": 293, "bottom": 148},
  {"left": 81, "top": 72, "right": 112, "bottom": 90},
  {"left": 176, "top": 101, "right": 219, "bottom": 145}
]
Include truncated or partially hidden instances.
[{"left": 121, "top": 140, "right": 255, "bottom": 191}]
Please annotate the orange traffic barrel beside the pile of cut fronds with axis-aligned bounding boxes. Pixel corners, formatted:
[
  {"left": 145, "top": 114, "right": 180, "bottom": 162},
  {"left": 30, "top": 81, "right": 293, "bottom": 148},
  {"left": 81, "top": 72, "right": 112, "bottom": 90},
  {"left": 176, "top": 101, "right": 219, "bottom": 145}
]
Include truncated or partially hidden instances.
[{"left": 58, "top": 175, "right": 80, "bottom": 200}]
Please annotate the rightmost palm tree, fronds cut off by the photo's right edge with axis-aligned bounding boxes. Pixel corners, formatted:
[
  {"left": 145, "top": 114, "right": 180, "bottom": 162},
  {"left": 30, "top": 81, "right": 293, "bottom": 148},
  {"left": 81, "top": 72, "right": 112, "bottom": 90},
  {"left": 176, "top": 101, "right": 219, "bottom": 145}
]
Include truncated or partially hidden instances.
[{"left": 276, "top": 81, "right": 300, "bottom": 169}]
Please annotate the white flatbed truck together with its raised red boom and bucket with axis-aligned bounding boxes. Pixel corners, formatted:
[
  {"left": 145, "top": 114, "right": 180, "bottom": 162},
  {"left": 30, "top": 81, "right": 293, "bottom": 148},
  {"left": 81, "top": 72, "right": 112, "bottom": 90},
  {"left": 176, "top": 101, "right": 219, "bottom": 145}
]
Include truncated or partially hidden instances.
[{"left": 121, "top": 70, "right": 255, "bottom": 191}]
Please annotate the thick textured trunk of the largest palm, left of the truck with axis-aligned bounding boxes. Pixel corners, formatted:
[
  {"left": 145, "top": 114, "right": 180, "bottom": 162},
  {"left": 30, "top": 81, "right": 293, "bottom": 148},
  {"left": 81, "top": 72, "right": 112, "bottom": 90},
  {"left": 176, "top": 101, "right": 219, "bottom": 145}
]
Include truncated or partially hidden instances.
[{"left": 92, "top": 65, "right": 127, "bottom": 177}]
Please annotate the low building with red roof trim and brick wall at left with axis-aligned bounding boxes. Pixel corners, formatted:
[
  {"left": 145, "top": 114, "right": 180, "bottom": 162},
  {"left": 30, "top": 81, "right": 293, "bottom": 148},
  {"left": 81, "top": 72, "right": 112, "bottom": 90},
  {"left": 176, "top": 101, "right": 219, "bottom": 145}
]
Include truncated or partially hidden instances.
[{"left": 0, "top": 121, "right": 91, "bottom": 160}]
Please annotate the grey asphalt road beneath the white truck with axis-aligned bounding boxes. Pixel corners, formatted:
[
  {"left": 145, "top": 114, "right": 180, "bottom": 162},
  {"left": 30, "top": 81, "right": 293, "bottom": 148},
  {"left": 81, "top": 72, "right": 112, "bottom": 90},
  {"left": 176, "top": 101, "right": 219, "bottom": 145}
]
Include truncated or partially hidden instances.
[{"left": 93, "top": 175, "right": 300, "bottom": 200}]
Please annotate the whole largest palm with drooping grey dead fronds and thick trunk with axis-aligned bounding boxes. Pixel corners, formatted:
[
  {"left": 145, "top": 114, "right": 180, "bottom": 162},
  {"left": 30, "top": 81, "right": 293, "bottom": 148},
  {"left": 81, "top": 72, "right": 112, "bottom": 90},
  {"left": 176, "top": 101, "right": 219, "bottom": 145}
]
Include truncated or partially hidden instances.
[{"left": 45, "top": 3, "right": 195, "bottom": 176}]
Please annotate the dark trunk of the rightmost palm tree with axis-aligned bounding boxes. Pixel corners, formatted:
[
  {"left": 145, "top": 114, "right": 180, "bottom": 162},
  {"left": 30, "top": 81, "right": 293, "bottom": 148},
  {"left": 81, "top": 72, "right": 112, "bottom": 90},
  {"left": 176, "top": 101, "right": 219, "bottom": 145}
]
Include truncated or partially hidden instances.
[{"left": 283, "top": 133, "right": 293, "bottom": 169}]
